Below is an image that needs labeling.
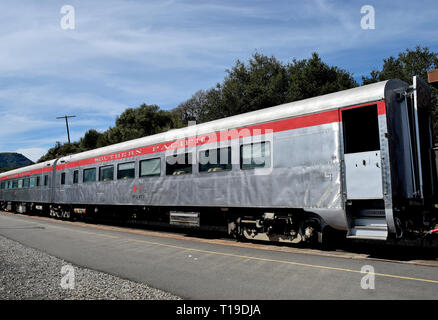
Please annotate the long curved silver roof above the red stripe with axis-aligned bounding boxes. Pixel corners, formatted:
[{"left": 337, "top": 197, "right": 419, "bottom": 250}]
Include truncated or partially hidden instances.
[{"left": 0, "top": 80, "right": 403, "bottom": 177}]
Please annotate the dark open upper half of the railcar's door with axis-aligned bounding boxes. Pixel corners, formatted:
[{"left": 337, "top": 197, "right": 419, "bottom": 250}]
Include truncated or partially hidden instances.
[{"left": 342, "top": 105, "right": 380, "bottom": 153}]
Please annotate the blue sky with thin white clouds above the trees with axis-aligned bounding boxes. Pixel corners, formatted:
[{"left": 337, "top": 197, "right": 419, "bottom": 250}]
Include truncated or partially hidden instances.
[{"left": 0, "top": 0, "right": 438, "bottom": 161}]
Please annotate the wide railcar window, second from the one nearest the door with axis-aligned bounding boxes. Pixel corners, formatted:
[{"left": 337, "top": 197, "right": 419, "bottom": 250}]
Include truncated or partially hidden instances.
[{"left": 199, "top": 147, "right": 231, "bottom": 172}]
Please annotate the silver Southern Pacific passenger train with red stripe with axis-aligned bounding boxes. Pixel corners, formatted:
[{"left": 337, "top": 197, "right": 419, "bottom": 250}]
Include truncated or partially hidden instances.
[{"left": 0, "top": 77, "right": 436, "bottom": 243}]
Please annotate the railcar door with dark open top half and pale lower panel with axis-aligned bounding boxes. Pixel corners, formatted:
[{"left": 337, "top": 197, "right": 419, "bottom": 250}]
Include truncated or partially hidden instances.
[{"left": 341, "top": 104, "right": 383, "bottom": 200}]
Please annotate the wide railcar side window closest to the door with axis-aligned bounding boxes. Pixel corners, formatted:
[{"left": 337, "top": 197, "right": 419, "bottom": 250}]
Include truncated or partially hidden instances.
[{"left": 240, "top": 141, "right": 271, "bottom": 170}]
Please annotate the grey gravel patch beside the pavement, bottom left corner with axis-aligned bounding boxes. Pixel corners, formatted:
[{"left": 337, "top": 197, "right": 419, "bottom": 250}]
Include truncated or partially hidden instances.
[{"left": 0, "top": 236, "right": 181, "bottom": 300}]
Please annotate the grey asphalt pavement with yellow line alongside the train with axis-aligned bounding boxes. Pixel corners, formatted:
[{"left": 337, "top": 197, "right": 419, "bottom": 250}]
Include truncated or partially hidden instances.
[{"left": 0, "top": 213, "right": 438, "bottom": 300}]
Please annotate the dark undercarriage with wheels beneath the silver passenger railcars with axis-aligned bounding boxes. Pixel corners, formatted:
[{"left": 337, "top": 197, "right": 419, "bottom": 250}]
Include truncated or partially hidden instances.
[{"left": 0, "top": 202, "right": 326, "bottom": 243}]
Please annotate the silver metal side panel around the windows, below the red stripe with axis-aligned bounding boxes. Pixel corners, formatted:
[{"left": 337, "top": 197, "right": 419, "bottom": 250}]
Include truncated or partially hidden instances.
[{"left": 55, "top": 122, "right": 342, "bottom": 209}]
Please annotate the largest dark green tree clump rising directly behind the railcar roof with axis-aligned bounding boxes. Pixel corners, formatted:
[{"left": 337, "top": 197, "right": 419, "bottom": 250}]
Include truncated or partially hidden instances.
[{"left": 175, "top": 53, "right": 358, "bottom": 123}]
